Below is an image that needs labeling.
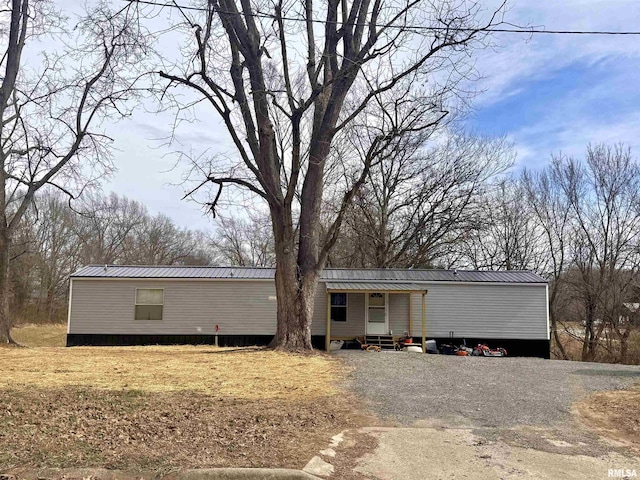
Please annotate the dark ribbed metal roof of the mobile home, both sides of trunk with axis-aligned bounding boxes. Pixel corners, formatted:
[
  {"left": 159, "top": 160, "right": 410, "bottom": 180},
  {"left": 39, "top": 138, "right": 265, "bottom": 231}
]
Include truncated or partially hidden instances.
[{"left": 71, "top": 265, "right": 547, "bottom": 283}]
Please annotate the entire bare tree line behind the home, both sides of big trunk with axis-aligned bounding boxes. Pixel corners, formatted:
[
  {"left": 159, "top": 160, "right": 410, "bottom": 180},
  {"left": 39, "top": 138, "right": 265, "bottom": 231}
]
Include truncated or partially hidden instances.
[{"left": 6, "top": 141, "right": 640, "bottom": 362}]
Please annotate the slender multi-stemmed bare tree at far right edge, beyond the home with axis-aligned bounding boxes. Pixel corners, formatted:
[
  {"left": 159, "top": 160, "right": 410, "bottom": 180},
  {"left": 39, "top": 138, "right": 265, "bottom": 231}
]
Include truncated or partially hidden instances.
[{"left": 558, "top": 144, "right": 640, "bottom": 361}]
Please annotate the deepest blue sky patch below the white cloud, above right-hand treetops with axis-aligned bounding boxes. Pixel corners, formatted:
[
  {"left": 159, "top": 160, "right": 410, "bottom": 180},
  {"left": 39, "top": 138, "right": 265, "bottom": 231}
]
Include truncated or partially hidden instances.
[{"left": 464, "top": 59, "right": 640, "bottom": 168}]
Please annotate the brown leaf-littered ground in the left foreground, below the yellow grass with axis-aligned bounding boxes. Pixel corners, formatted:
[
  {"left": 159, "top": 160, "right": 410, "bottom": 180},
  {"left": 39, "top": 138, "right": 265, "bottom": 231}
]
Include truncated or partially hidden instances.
[{"left": 0, "top": 387, "right": 365, "bottom": 473}]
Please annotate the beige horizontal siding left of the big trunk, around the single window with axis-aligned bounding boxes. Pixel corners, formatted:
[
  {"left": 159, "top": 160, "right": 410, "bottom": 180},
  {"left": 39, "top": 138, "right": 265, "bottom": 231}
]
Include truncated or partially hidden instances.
[{"left": 69, "top": 279, "right": 277, "bottom": 335}]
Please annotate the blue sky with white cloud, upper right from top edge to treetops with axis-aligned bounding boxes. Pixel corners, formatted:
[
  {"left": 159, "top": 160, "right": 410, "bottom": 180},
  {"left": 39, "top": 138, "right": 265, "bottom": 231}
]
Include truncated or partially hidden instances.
[{"left": 465, "top": 0, "right": 640, "bottom": 168}]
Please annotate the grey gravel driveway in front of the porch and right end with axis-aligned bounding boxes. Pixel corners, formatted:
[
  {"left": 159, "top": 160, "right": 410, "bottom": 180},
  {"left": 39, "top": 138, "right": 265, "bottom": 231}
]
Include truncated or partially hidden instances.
[{"left": 337, "top": 350, "right": 640, "bottom": 427}]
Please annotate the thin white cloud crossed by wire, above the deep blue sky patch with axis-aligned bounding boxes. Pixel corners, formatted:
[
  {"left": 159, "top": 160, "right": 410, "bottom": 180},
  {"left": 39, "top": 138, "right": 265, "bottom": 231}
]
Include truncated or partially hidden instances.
[{"left": 476, "top": 0, "right": 640, "bottom": 107}]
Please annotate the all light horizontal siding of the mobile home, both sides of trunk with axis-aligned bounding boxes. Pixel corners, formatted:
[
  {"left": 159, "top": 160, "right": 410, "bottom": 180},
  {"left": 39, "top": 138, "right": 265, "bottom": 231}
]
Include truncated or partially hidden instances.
[{"left": 69, "top": 278, "right": 548, "bottom": 340}]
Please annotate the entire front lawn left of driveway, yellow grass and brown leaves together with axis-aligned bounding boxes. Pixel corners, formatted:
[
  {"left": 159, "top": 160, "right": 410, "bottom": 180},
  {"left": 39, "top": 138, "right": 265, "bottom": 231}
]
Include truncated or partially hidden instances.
[{"left": 0, "top": 326, "right": 364, "bottom": 473}]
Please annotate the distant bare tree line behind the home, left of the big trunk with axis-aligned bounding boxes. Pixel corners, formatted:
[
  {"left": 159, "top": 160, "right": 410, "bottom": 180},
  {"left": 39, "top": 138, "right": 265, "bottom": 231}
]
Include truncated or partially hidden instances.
[{"left": 10, "top": 190, "right": 273, "bottom": 323}]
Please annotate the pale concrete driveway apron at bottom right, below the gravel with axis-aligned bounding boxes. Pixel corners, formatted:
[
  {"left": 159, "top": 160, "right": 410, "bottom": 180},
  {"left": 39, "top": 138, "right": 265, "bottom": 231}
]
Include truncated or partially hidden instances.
[{"left": 355, "top": 428, "right": 640, "bottom": 480}]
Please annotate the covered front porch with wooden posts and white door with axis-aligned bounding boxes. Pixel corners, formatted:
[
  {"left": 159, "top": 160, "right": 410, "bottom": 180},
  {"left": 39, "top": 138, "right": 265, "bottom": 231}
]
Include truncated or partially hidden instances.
[{"left": 325, "top": 282, "right": 427, "bottom": 352}]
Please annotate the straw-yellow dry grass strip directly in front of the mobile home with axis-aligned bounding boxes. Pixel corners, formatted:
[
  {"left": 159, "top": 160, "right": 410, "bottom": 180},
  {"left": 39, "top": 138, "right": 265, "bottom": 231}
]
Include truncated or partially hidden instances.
[{"left": 0, "top": 346, "right": 342, "bottom": 400}]
